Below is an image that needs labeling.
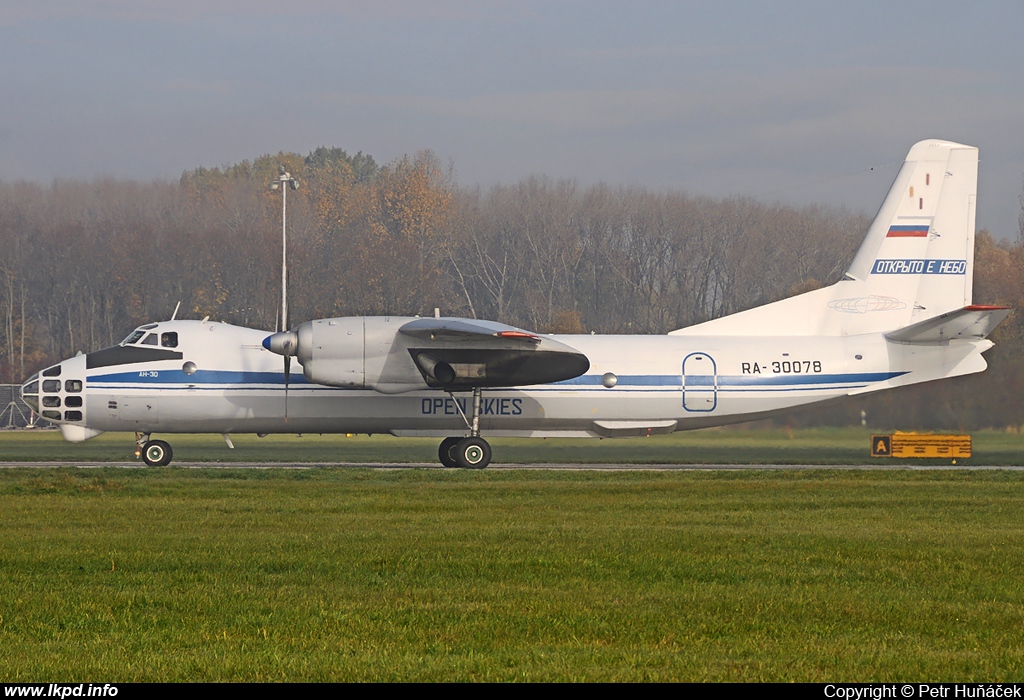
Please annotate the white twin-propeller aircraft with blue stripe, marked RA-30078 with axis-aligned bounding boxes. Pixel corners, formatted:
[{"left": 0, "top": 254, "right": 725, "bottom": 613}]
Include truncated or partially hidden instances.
[{"left": 22, "top": 140, "right": 1009, "bottom": 469}]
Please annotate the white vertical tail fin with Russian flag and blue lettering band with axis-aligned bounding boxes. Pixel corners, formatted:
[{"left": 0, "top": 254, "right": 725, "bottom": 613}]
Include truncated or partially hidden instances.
[{"left": 673, "top": 140, "right": 978, "bottom": 336}]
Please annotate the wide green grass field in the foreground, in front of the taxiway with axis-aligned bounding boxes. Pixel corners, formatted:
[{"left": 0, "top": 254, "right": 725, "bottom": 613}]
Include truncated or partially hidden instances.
[{"left": 0, "top": 468, "right": 1024, "bottom": 682}]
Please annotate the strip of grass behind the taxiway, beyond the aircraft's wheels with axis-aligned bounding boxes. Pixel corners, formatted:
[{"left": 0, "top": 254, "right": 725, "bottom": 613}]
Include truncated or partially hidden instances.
[{"left": 6, "top": 421, "right": 1024, "bottom": 466}]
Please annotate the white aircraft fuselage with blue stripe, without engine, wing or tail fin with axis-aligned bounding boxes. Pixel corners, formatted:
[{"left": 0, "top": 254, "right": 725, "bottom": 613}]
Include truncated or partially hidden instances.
[{"left": 41, "top": 320, "right": 990, "bottom": 440}]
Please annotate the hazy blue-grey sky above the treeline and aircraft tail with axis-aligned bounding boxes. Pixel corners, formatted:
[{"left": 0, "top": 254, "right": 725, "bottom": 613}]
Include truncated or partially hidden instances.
[{"left": 0, "top": 0, "right": 1024, "bottom": 239}]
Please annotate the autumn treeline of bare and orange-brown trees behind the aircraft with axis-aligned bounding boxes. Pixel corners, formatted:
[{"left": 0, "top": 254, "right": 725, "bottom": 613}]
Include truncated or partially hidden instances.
[{"left": 0, "top": 148, "right": 1024, "bottom": 426}]
